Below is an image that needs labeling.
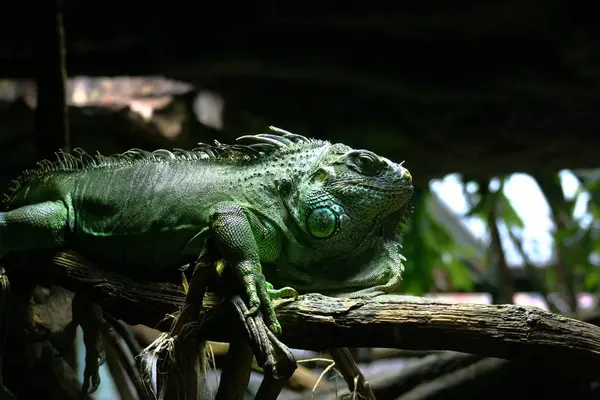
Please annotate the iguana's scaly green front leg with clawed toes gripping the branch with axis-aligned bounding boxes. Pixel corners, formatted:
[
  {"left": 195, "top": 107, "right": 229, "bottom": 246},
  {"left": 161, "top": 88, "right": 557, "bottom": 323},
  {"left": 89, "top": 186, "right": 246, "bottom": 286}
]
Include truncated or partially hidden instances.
[{"left": 209, "top": 203, "right": 297, "bottom": 335}]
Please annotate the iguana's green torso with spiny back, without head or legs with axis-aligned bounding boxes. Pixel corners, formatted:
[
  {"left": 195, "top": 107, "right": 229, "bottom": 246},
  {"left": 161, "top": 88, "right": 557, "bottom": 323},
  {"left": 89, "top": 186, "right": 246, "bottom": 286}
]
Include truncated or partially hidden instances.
[{"left": 0, "top": 142, "right": 319, "bottom": 268}]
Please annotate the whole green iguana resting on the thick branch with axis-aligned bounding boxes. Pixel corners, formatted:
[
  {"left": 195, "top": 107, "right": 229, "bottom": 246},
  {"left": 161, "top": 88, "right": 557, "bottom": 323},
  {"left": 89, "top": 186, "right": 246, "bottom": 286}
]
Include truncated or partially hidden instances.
[{"left": 0, "top": 128, "right": 413, "bottom": 334}]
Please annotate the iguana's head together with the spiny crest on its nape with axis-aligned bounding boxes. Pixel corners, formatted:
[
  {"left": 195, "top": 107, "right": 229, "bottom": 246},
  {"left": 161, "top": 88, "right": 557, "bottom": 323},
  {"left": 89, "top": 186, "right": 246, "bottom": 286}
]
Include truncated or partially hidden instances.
[{"left": 237, "top": 127, "right": 414, "bottom": 253}]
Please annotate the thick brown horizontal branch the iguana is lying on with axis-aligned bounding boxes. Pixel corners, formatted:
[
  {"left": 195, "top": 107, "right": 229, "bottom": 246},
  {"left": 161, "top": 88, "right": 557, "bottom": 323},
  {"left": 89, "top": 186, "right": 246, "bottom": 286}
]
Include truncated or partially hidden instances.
[{"left": 22, "top": 252, "right": 600, "bottom": 375}]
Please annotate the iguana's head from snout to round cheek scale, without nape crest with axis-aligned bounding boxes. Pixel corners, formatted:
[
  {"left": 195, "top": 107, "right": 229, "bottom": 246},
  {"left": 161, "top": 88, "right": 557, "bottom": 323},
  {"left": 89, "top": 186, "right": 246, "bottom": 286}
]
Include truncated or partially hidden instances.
[{"left": 293, "top": 144, "right": 414, "bottom": 249}]
